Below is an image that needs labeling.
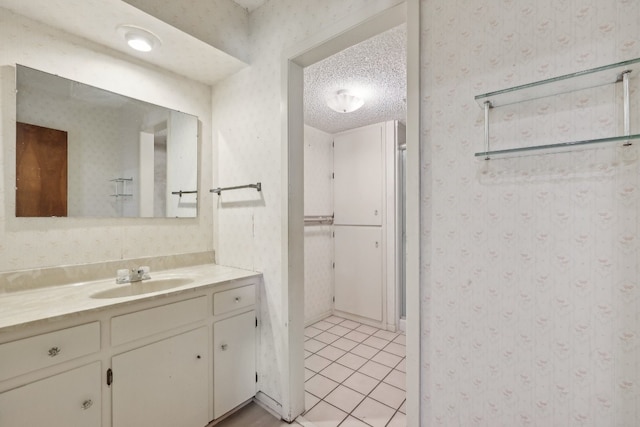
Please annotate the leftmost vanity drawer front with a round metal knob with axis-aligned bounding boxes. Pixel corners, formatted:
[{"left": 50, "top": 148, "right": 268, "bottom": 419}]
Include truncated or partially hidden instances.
[{"left": 0, "top": 322, "right": 100, "bottom": 381}]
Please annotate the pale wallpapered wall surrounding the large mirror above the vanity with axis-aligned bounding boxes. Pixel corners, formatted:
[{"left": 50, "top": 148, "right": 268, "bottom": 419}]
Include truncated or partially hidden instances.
[{"left": 0, "top": 10, "right": 213, "bottom": 271}]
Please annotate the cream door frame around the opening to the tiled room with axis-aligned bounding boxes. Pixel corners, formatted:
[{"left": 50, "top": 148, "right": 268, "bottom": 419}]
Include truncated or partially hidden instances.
[{"left": 279, "top": 0, "right": 421, "bottom": 426}]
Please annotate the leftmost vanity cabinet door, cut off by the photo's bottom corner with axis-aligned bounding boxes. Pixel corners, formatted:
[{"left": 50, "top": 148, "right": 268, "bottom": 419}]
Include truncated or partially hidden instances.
[{"left": 0, "top": 362, "right": 102, "bottom": 427}]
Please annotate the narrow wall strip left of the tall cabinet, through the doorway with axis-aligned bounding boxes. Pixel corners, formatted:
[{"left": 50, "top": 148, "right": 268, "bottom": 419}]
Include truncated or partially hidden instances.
[{"left": 304, "top": 126, "right": 333, "bottom": 324}]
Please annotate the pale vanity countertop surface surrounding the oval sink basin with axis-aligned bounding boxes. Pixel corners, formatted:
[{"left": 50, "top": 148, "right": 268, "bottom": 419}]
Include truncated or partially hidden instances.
[{"left": 0, "top": 264, "right": 261, "bottom": 333}]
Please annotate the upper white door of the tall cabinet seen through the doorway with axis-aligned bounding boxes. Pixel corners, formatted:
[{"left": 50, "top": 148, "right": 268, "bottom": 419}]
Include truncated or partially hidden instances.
[{"left": 333, "top": 124, "right": 384, "bottom": 225}]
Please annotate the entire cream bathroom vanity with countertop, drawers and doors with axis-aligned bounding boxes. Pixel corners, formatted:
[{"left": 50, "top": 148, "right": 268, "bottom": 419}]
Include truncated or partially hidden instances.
[{"left": 0, "top": 264, "right": 261, "bottom": 427}]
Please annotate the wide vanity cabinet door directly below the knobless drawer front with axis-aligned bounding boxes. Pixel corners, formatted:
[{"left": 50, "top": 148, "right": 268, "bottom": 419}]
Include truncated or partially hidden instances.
[{"left": 111, "top": 327, "right": 209, "bottom": 427}]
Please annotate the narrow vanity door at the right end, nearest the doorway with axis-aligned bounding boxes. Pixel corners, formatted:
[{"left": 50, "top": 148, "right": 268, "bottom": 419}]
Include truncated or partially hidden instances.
[{"left": 213, "top": 311, "right": 256, "bottom": 418}]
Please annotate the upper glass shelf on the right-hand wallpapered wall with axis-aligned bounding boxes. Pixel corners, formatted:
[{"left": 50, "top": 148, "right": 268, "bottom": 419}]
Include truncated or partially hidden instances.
[{"left": 475, "top": 58, "right": 640, "bottom": 108}]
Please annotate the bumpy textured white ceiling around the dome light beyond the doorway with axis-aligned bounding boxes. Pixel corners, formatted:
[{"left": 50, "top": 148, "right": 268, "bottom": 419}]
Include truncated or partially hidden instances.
[{"left": 304, "top": 24, "right": 407, "bottom": 133}]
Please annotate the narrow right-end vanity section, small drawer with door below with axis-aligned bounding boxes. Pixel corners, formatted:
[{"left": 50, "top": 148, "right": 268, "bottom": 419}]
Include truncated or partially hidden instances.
[{"left": 213, "top": 285, "right": 258, "bottom": 419}]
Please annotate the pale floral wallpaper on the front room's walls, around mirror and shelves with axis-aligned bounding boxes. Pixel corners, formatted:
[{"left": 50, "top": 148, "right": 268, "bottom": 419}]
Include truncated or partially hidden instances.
[{"left": 0, "top": 0, "right": 640, "bottom": 426}]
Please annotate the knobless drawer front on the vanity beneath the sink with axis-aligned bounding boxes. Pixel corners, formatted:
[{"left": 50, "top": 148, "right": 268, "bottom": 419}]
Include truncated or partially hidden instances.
[{"left": 111, "top": 296, "right": 207, "bottom": 345}]
